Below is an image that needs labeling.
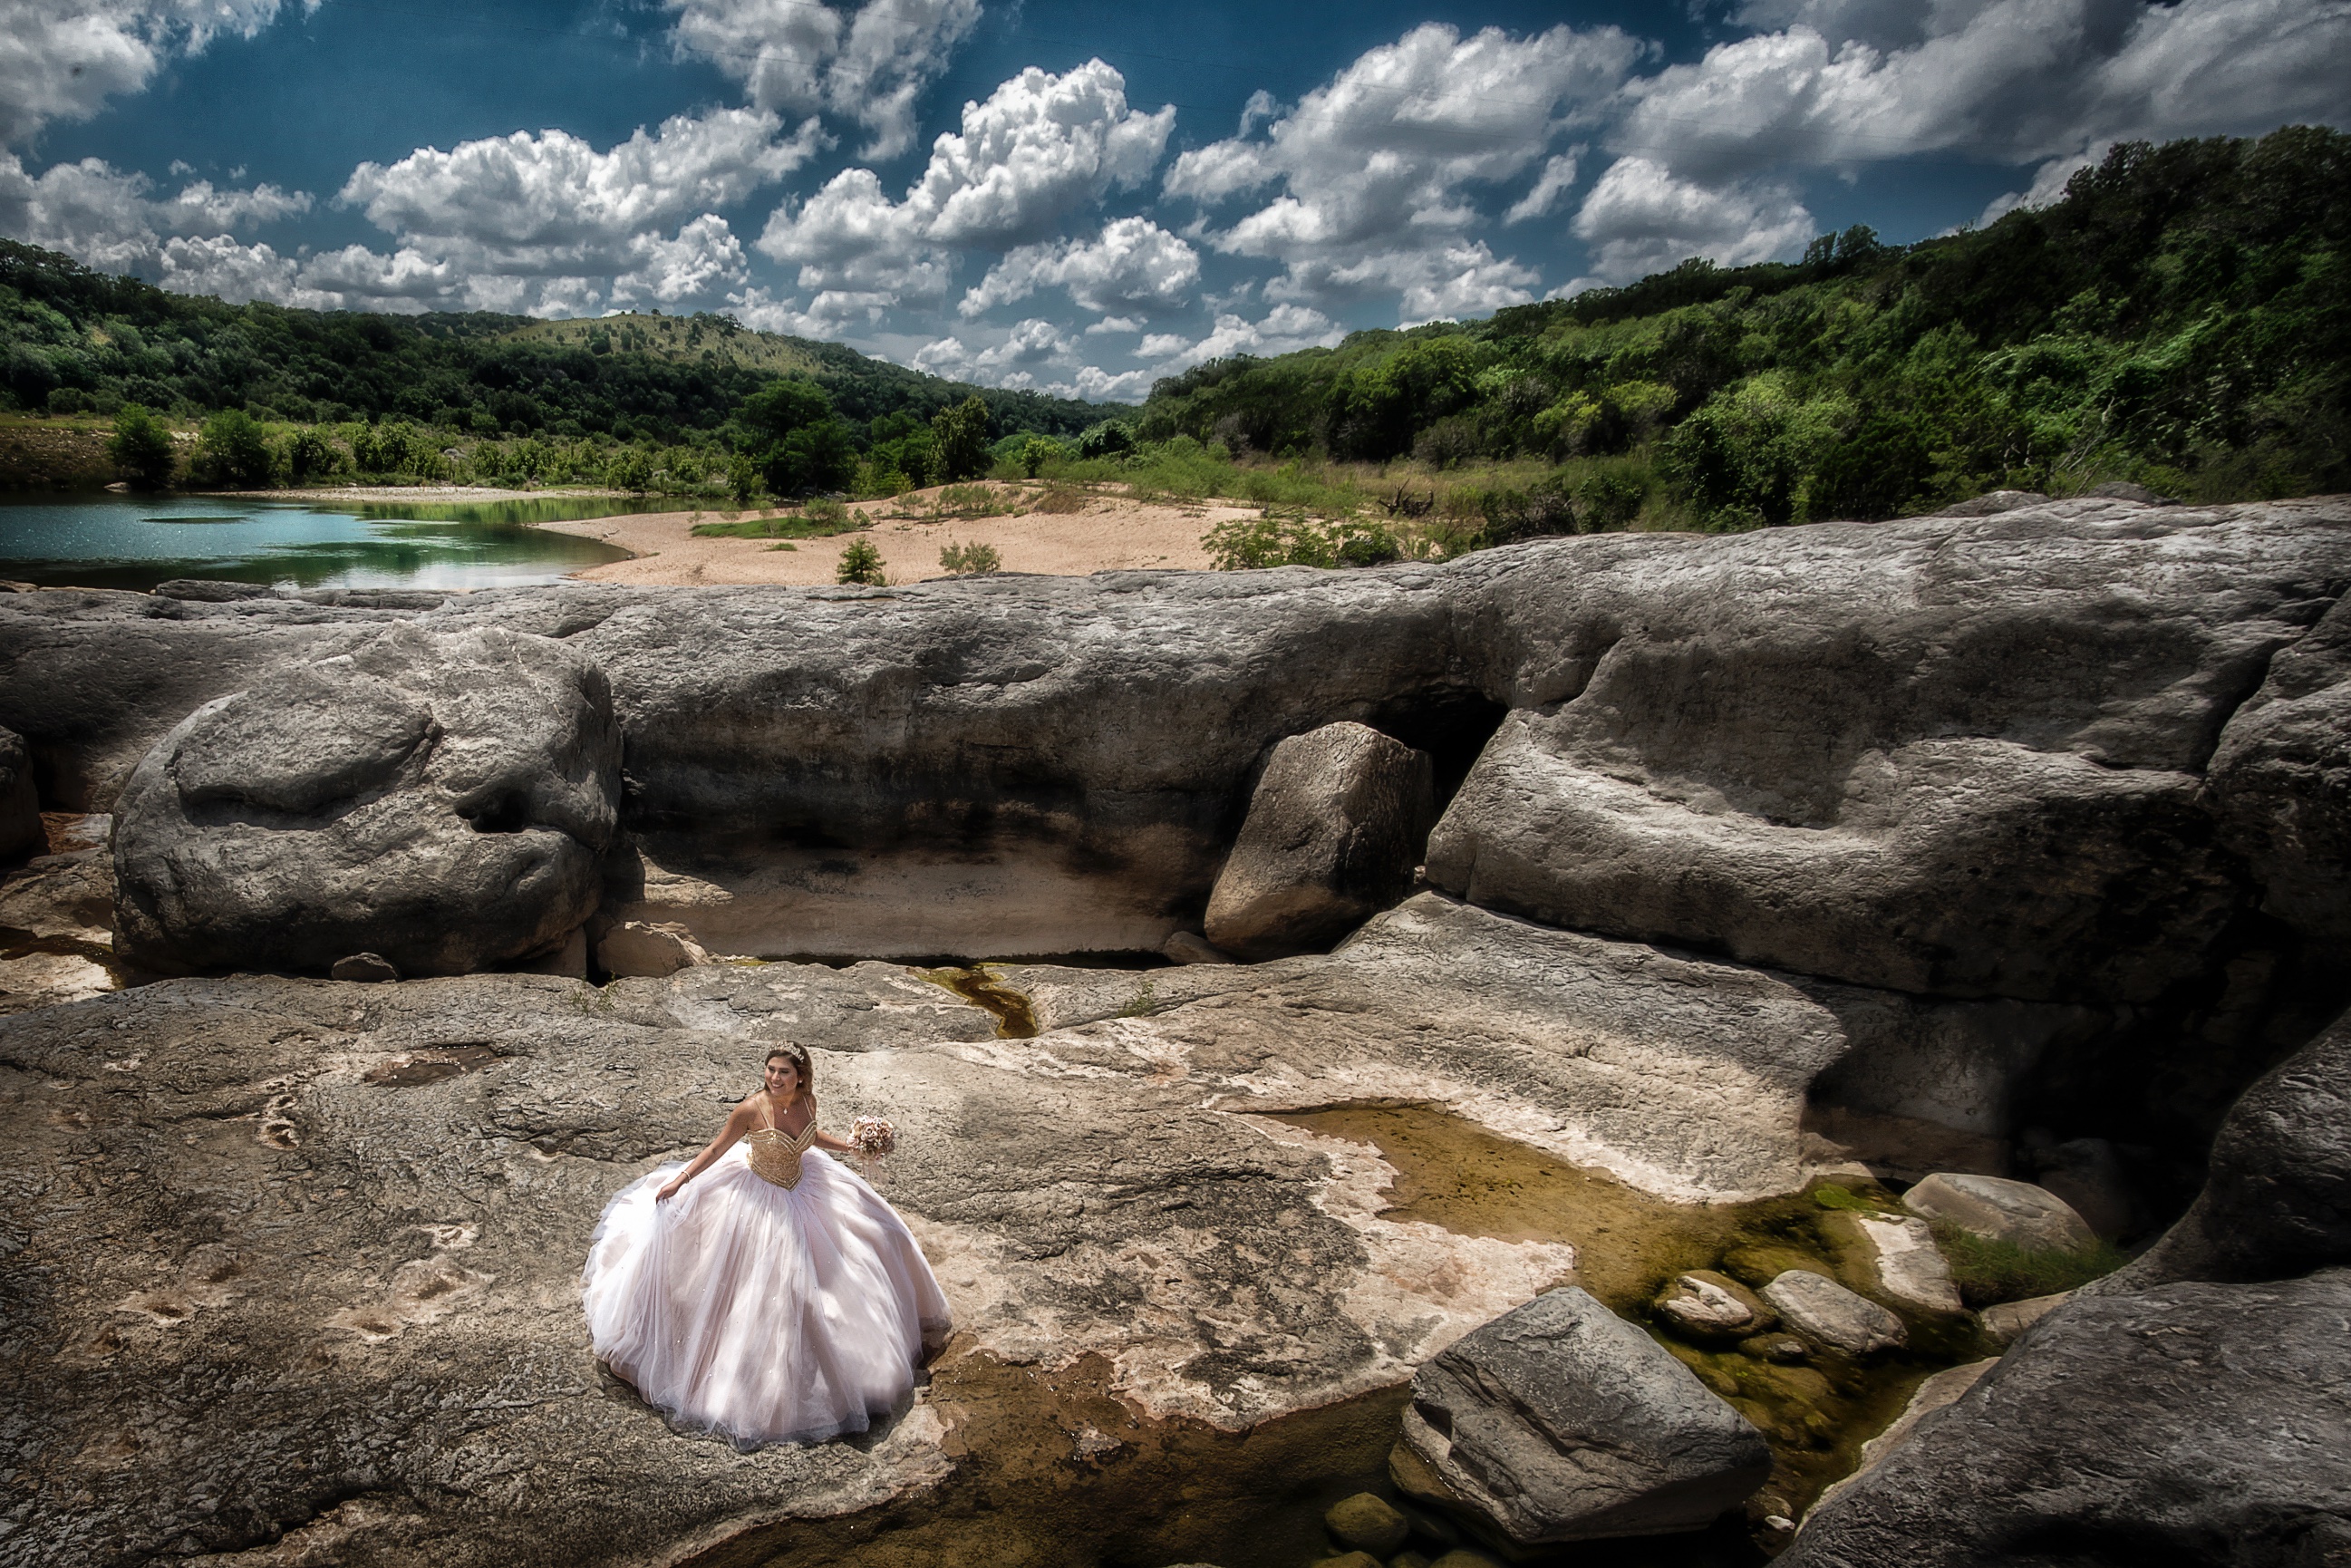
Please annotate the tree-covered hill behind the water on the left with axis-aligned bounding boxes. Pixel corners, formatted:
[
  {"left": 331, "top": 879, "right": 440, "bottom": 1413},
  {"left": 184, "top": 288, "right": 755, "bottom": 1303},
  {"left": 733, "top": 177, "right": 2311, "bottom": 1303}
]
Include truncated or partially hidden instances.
[{"left": 0, "top": 240, "right": 1124, "bottom": 482}]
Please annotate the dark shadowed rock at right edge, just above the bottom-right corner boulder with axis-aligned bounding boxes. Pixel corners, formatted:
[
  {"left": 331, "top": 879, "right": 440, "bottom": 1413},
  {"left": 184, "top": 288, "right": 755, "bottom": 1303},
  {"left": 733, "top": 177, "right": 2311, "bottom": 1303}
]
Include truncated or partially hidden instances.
[{"left": 2083, "top": 1013, "right": 2351, "bottom": 1295}]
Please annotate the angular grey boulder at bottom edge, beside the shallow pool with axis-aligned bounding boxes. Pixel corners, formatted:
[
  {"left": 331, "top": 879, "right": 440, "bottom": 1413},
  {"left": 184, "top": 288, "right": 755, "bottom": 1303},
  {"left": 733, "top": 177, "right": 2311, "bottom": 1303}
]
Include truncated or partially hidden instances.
[{"left": 1404, "top": 1286, "right": 1770, "bottom": 1547}]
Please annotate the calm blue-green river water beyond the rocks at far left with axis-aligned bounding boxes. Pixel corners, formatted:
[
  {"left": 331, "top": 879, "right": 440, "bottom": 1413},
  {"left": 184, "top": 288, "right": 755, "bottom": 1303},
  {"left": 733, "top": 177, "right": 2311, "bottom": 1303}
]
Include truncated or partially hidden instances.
[{"left": 0, "top": 494, "right": 643, "bottom": 590}]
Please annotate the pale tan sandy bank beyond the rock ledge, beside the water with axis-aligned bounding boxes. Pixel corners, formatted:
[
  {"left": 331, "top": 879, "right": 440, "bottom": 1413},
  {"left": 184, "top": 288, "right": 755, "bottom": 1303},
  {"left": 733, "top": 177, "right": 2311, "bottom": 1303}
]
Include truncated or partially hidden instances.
[{"left": 536, "top": 484, "right": 1255, "bottom": 586}]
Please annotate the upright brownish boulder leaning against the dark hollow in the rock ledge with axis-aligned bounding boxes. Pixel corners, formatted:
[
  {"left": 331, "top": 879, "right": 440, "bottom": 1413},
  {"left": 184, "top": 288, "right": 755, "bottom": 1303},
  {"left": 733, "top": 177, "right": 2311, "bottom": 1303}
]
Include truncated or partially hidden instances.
[{"left": 1206, "top": 724, "right": 1437, "bottom": 959}]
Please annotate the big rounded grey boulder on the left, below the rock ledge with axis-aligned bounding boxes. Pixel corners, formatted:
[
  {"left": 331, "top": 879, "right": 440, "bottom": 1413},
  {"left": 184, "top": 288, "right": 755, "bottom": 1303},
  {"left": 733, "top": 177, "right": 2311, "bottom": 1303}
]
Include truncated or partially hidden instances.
[{"left": 115, "top": 628, "right": 621, "bottom": 975}]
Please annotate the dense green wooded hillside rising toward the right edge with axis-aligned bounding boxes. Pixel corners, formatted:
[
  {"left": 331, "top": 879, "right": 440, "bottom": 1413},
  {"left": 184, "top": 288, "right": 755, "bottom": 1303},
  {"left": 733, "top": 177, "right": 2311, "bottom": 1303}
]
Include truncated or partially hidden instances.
[{"left": 1136, "top": 127, "right": 2351, "bottom": 541}]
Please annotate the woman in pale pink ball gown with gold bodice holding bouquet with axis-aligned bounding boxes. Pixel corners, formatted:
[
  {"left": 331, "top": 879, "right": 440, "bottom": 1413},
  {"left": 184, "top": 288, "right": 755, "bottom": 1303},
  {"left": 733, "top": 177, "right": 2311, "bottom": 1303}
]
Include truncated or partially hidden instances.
[{"left": 581, "top": 1046, "right": 947, "bottom": 1448}]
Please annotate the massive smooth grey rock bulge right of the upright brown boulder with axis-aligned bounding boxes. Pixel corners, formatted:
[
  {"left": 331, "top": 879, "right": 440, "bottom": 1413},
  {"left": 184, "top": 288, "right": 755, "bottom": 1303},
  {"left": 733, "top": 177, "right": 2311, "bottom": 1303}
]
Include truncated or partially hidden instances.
[{"left": 1427, "top": 498, "right": 2351, "bottom": 1002}]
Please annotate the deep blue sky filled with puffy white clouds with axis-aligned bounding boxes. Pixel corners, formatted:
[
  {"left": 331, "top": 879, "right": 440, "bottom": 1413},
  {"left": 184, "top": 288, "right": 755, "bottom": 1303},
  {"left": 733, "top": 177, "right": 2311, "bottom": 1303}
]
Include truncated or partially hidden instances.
[{"left": 0, "top": 0, "right": 2351, "bottom": 400}]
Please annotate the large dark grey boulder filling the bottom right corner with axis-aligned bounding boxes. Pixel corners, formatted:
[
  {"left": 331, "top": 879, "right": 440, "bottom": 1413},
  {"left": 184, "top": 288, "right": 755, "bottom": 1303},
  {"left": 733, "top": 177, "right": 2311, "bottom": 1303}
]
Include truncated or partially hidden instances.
[{"left": 1780, "top": 1270, "right": 2351, "bottom": 1568}]
